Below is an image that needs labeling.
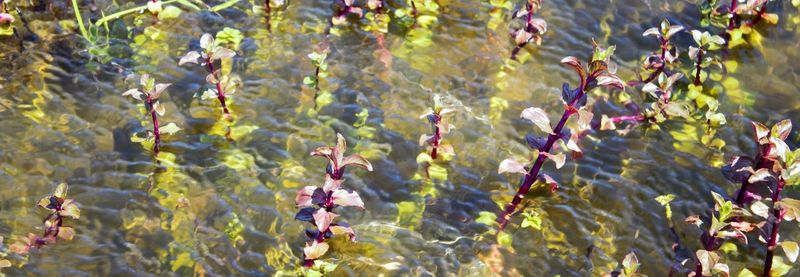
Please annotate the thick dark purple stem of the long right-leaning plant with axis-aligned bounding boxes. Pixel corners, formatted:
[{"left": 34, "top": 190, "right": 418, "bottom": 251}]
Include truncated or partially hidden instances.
[{"left": 497, "top": 74, "right": 591, "bottom": 231}]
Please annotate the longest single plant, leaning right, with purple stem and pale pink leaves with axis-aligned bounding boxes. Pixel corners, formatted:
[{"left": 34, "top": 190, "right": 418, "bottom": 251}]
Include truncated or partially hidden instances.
[{"left": 497, "top": 42, "right": 625, "bottom": 231}]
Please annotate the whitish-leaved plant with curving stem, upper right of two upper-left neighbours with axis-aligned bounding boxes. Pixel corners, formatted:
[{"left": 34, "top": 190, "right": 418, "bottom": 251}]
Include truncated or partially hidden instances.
[{"left": 178, "top": 33, "right": 241, "bottom": 120}]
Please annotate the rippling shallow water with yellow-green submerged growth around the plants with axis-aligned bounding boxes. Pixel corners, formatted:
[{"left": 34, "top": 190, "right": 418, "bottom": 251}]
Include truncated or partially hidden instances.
[{"left": 0, "top": 0, "right": 800, "bottom": 276}]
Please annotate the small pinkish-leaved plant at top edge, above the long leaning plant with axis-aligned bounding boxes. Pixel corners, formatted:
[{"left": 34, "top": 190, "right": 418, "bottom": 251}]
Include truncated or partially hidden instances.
[{"left": 509, "top": 0, "right": 547, "bottom": 60}]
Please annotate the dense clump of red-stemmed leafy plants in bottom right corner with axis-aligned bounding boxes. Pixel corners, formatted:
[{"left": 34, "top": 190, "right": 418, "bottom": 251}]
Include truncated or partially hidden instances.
[{"left": 686, "top": 119, "right": 800, "bottom": 276}]
